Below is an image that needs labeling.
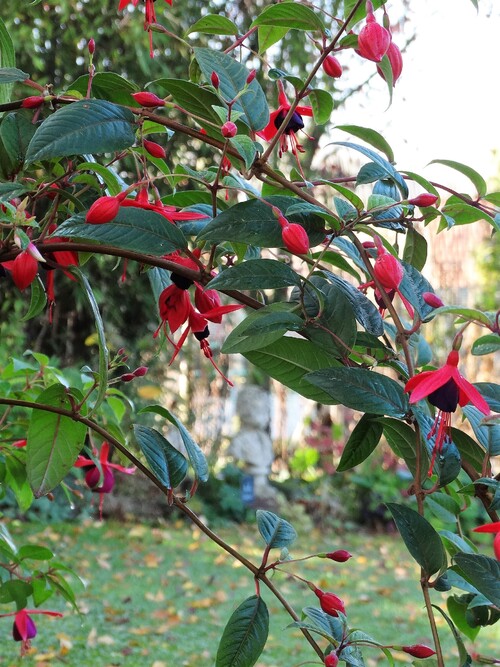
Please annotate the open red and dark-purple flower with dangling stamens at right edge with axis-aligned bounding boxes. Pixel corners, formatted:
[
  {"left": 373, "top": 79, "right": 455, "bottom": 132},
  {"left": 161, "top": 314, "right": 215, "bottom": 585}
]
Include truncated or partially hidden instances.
[{"left": 405, "top": 350, "right": 490, "bottom": 475}]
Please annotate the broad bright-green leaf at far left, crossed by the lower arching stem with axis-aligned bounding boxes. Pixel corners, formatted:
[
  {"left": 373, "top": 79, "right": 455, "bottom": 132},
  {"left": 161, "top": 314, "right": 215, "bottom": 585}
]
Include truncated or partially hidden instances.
[{"left": 26, "top": 384, "right": 87, "bottom": 498}]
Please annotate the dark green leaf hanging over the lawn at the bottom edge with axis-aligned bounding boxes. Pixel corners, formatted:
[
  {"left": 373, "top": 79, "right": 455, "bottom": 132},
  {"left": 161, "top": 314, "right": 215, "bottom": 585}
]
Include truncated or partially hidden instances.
[{"left": 215, "top": 595, "right": 269, "bottom": 667}]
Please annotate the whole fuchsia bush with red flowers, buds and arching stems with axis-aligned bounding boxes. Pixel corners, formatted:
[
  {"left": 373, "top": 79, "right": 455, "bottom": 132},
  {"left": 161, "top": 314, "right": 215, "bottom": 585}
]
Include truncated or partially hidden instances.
[{"left": 0, "top": 0, "right": 500, "bottom": 667}]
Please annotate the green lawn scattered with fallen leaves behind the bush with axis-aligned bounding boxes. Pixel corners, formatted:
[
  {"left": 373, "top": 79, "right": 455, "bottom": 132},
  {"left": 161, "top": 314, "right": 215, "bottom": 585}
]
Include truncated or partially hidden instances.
[{"left": 0, "top": 522, "right": 498, "bottom": 667}]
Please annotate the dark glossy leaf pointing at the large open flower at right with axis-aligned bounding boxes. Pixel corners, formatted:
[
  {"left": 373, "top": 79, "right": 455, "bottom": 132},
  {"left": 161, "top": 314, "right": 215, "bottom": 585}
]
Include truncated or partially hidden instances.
[{"left": 305, "top": 368, "right": 408, "bottom": 417}]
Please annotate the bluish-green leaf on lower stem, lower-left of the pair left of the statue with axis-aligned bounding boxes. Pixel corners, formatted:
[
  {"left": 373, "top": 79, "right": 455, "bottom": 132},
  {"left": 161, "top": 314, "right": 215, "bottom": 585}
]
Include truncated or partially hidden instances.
[{"left": 134, "top": 424, "right": 188, "bottom": 489}]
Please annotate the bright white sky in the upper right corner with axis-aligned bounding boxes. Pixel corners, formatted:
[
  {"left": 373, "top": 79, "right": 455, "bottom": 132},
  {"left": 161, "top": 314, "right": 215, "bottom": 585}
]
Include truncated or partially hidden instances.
[{"left": 332, "top": 0, "right": 500, "bottom": 189}]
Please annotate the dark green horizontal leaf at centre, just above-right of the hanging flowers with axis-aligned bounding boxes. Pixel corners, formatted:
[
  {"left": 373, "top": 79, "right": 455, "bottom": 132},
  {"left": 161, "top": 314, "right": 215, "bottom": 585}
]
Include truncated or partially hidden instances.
[{"left": 207, "top": 259, "right": 301, "bottom": 290}]
